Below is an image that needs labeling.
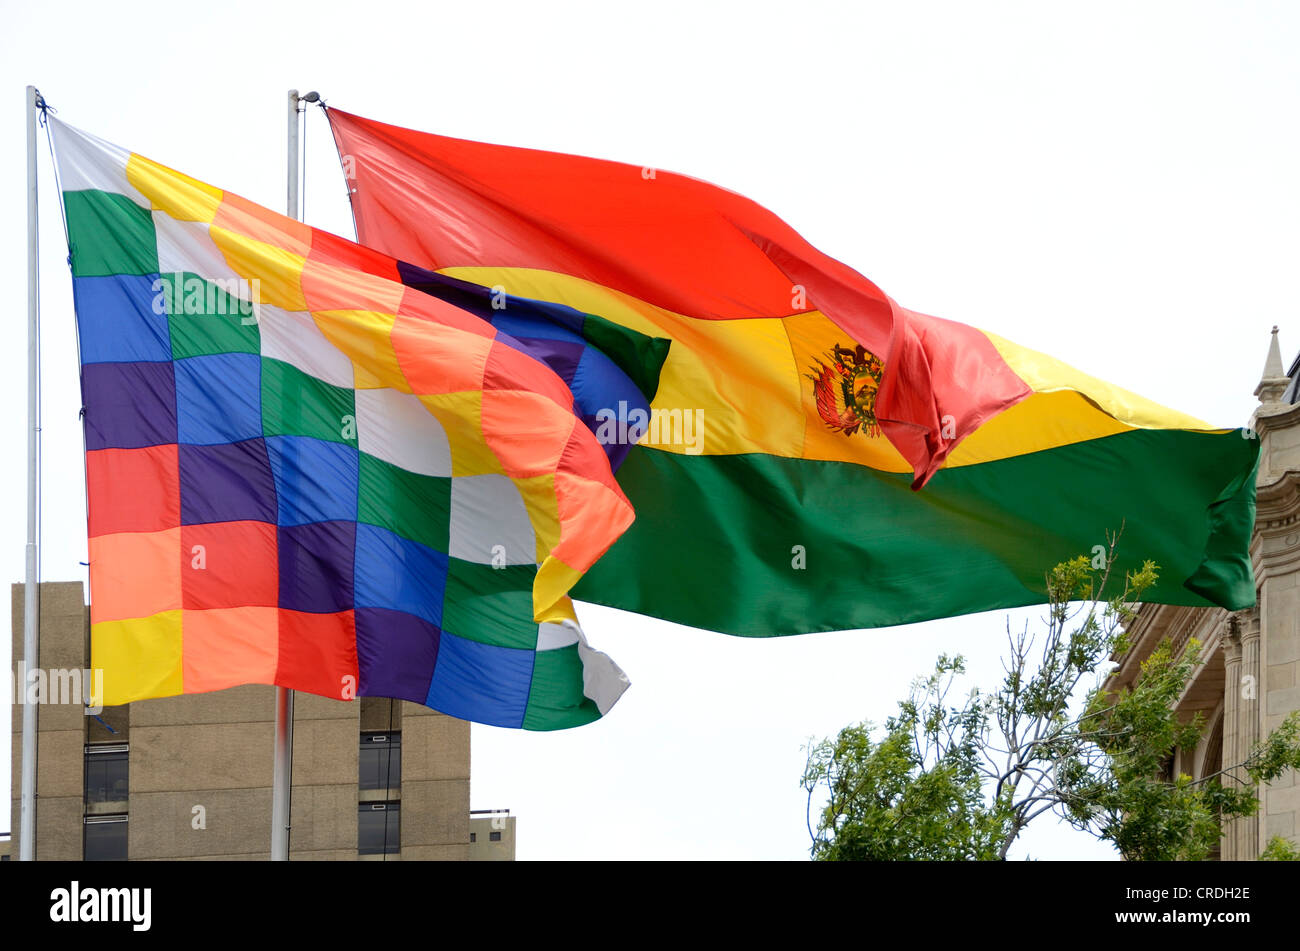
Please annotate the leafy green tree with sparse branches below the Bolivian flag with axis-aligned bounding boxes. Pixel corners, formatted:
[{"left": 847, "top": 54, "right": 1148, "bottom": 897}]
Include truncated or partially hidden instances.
[{"left": 802, "top": 537, "right": 1300, "bottom": 860}]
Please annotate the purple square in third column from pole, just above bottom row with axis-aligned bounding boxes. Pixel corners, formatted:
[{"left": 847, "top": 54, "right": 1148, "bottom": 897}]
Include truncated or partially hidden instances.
[{"left": 277, "top": 522, "right": 356, "bottom": 615}]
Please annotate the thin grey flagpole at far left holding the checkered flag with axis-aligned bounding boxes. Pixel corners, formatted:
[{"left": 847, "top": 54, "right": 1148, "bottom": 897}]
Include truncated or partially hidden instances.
[{"left": 14, "top": 86, "right": 44, "bottom": 861}]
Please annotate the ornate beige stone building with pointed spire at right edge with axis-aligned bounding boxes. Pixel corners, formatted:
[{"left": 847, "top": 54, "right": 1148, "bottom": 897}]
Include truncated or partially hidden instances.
[{"left": 1110, "top": 327, "right": 1300, "bottom": 860}]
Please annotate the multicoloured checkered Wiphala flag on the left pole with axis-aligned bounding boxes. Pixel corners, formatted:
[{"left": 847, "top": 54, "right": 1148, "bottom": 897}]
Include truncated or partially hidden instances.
[{"left": 47, "top": 117, "right": 647, "bottom": 730}]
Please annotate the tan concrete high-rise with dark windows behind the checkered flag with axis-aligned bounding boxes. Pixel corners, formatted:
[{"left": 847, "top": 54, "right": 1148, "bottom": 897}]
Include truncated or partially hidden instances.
[{"left": 9, "top": 582, "right": 515, "bottom": 861}]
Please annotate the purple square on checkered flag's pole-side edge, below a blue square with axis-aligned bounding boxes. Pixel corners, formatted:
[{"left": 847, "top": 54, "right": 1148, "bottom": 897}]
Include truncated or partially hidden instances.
[{"left": 82, "top": 361, "right": 177, "bottom": 450}]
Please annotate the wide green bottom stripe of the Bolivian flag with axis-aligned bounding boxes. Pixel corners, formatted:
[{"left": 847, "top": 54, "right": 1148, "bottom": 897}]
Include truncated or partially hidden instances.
[{"left": 573, "top": 430, "right": 1258, "bottom": 637}]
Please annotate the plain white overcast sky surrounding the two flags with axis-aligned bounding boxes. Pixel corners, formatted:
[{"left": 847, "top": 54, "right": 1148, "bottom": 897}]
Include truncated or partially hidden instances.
[{"left": 0, "top": 0, "right": 1300, "bottom": 859}]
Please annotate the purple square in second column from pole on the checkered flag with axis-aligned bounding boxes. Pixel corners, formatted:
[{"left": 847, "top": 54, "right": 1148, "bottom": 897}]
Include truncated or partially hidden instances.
[{"left": 178, "top": 439, "right": 276, "bottom": 525}]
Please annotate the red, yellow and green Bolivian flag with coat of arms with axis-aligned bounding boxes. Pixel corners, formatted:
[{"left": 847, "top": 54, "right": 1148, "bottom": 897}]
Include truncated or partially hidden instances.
[{"left": 329, "top": 109, "right": 1258, "bottom": 635}]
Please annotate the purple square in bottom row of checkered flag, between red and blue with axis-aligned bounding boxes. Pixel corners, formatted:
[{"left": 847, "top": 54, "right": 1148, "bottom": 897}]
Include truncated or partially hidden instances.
[{"left": 356, "top": 608, "right": 442, "bottom": 703}]
